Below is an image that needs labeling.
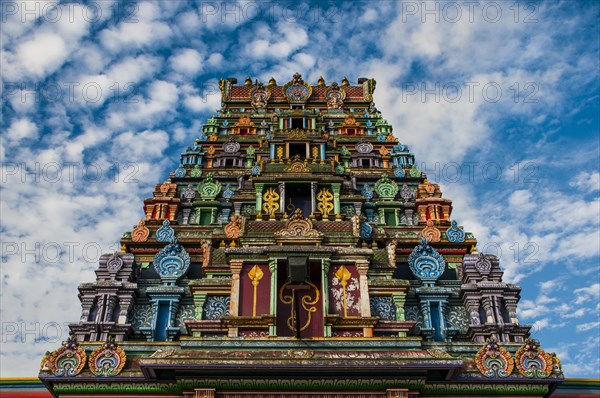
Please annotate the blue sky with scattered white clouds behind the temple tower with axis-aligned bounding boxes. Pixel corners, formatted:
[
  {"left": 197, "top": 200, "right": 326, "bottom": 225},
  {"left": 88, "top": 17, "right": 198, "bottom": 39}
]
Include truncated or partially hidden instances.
[{"left": 0, "top": 0, "right": 600, "bottom": 377}]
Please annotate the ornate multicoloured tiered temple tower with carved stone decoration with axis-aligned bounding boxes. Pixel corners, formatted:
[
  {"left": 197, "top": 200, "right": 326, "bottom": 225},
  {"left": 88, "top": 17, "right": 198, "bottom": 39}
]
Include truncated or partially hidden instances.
[{"left": 39, "top": 73, "right": 563, "bottom": 398}]
